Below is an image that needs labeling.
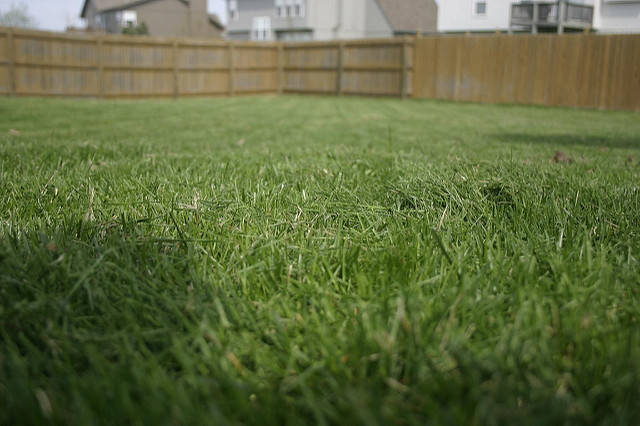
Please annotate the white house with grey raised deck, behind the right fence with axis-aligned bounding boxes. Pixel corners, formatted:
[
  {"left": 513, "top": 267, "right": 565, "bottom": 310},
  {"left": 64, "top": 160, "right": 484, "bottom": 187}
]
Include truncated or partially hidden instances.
[{"left": 438, "top": 0, "right": 640, "bottom": 33}]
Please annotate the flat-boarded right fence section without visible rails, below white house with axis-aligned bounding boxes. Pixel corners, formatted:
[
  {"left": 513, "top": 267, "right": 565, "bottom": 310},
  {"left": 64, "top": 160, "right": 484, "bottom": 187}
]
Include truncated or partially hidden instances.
[{"left": 414, "top": 34, "right": 640, "bottom": 111}]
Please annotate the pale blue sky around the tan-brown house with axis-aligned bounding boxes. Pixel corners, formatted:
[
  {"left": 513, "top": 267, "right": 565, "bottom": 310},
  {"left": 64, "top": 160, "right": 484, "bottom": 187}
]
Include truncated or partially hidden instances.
[{"left": 0, "top": 0, "right": 226, "bottom": 31}]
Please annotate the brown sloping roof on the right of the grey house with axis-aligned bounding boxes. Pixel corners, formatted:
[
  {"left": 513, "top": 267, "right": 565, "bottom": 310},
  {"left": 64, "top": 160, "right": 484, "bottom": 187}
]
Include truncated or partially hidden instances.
[{"left": 377, "top": 0, "right": 438, "bottom": 32}]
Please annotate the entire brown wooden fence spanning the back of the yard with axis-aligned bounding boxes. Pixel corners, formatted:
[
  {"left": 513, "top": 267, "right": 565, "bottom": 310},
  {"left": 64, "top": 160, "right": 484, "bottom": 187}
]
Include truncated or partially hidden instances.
[{"left": 0, "top": 28, "right": 640, "bottom": 111}]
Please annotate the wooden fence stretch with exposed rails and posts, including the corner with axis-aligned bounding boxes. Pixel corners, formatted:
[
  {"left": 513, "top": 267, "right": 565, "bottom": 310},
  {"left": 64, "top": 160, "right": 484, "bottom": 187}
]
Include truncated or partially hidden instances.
[{"left": 0, "top": 29, "right": 413, "bottom": 97}]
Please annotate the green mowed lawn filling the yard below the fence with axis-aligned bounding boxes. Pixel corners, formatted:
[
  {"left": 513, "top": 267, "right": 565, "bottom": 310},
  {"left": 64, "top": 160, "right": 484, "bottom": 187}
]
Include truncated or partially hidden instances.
[{"left": 0, "top": 97, "right": 640, "bottom": 425}]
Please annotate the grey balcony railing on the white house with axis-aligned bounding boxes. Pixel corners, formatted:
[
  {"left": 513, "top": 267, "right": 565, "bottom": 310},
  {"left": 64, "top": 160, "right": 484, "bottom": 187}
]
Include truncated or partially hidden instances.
[{"left": 511, "top": 1, "right": 593, "bottom": 32}]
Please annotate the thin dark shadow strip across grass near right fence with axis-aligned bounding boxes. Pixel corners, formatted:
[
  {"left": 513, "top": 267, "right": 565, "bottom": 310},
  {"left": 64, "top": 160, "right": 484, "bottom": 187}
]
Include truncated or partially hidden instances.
[{"left": 493, "top": 133, "right": 640, "bottom": 149}]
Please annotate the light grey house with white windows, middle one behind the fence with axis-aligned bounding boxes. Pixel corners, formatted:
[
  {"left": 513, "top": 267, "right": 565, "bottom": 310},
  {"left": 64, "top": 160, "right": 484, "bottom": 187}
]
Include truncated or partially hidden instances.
[{"left": 222, "top": 0, "right": 437, "bottom": 40}]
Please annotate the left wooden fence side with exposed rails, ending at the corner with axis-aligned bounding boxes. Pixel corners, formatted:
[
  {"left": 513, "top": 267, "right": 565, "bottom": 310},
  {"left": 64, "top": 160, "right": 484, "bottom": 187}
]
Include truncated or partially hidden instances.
[{"left": 0, "top": 29, "right": 279, "bottom": 97}]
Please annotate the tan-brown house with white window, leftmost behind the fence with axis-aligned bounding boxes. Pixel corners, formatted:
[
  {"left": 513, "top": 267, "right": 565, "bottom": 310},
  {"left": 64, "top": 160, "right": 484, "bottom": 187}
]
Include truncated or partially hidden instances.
[{"left": 80, "top": 0, "right": 224, "bottom": 38}]
